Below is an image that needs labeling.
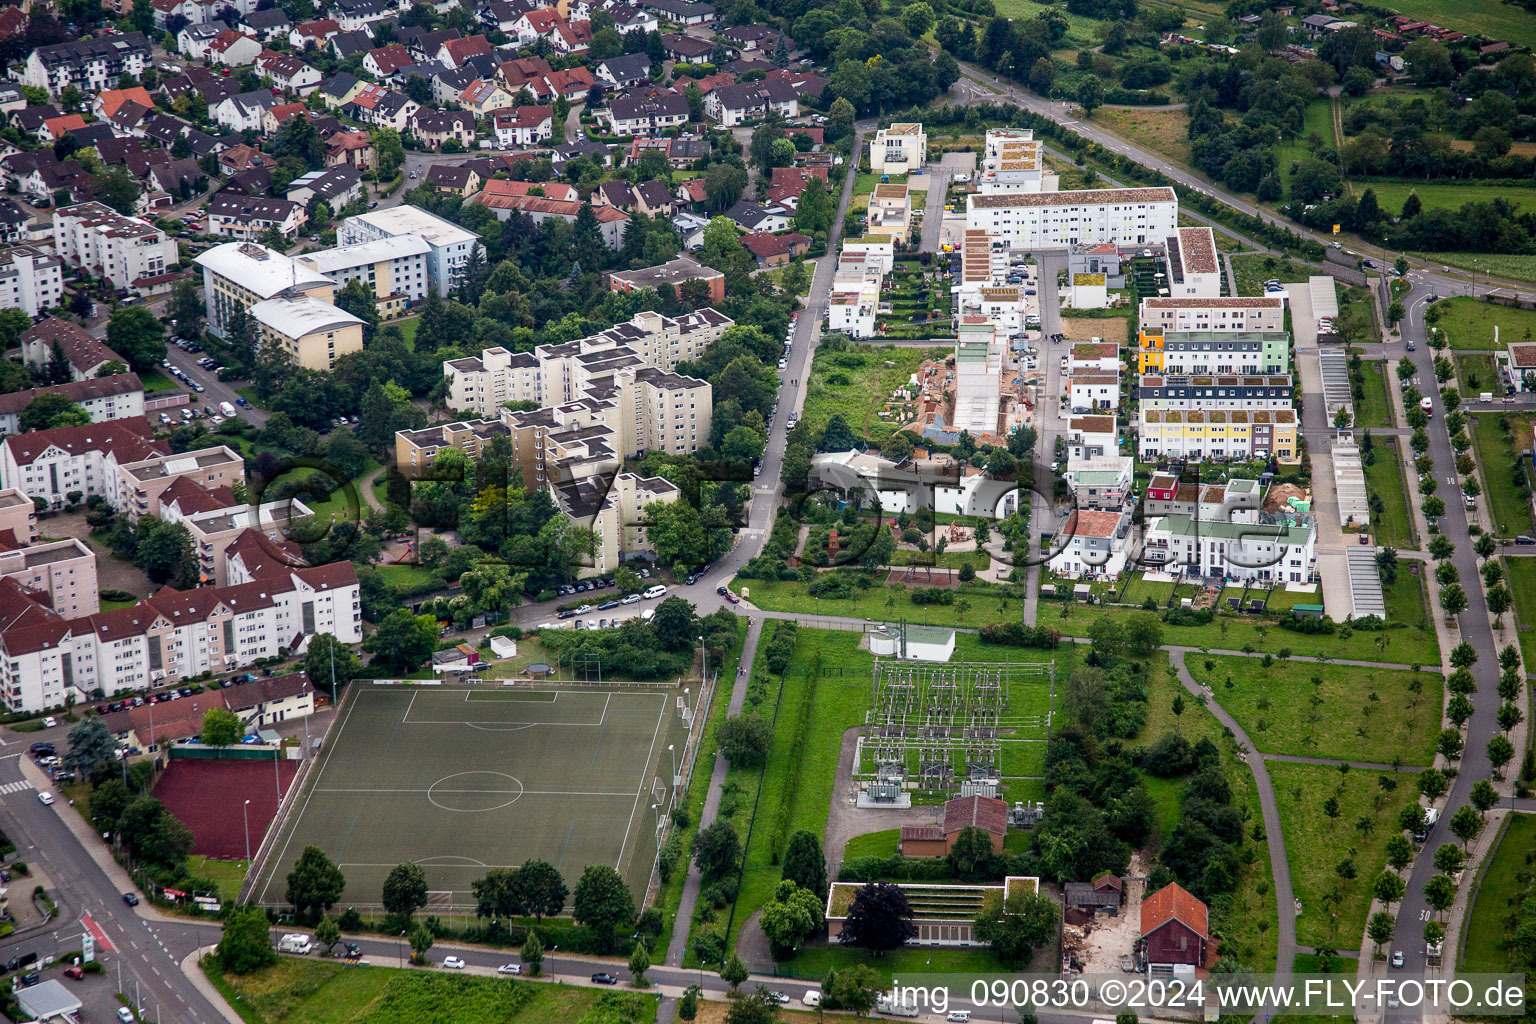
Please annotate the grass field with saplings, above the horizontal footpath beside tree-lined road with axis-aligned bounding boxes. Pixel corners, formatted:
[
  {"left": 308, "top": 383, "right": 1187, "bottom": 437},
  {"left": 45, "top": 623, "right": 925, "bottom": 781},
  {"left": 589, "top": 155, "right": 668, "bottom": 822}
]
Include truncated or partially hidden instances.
[{"left": 1186, "top": 657, "right": 1441, "bottom": 765}]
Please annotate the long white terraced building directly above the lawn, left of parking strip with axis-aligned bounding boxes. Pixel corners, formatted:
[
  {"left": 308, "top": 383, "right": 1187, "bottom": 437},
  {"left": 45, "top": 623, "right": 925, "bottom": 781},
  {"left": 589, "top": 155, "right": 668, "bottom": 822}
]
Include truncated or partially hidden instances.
[{"left": 1141, "top": 514, "right": 1316, "bottom": 583}]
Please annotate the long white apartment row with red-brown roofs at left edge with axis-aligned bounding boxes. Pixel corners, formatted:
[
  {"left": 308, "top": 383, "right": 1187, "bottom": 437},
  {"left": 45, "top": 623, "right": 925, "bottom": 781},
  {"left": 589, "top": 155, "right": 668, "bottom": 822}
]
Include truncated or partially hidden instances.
[{"left": 0, "top": 562, "right": 362, "bottom": 711}]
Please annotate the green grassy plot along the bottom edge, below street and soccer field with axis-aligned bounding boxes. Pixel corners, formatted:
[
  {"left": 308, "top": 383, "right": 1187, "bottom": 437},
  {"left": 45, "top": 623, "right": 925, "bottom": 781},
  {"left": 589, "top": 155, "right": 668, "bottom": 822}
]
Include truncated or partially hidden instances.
[{"left": 204, "top": 956, "right": 656, "bottom": 1024}]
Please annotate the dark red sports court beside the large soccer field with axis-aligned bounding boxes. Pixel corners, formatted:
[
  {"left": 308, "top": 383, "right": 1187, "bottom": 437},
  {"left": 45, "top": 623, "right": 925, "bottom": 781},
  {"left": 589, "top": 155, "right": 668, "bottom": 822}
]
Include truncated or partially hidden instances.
[{"left": 154, "top": 757, "right": 298, "bottom": 860}]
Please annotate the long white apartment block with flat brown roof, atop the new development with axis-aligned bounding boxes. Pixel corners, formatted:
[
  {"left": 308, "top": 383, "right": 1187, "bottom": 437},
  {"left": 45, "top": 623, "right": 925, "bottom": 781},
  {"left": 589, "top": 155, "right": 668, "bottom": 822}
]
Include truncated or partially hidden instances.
[{"left": 966, "top": 187, "right": 1178, "bottom": 249}]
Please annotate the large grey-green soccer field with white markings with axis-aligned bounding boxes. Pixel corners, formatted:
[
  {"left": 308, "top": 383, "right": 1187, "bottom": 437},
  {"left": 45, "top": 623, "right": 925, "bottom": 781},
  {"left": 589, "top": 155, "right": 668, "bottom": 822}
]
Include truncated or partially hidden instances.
[{"left": 253, "top": 683, "right": 687, "bottom": 912}]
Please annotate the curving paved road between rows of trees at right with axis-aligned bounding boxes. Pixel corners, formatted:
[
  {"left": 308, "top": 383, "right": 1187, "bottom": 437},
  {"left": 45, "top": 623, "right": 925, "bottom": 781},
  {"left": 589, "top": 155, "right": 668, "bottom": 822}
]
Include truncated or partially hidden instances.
[{"left": 1389, "top": 282, "right": 1499, "bottom": 994}]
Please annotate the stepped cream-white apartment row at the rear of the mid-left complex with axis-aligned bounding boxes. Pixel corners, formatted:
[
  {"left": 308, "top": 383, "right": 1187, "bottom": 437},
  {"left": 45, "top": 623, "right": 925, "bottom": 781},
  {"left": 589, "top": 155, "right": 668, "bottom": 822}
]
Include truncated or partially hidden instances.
[{"left": 442, "top": 307, "right": 734, "bottom": 418}]
